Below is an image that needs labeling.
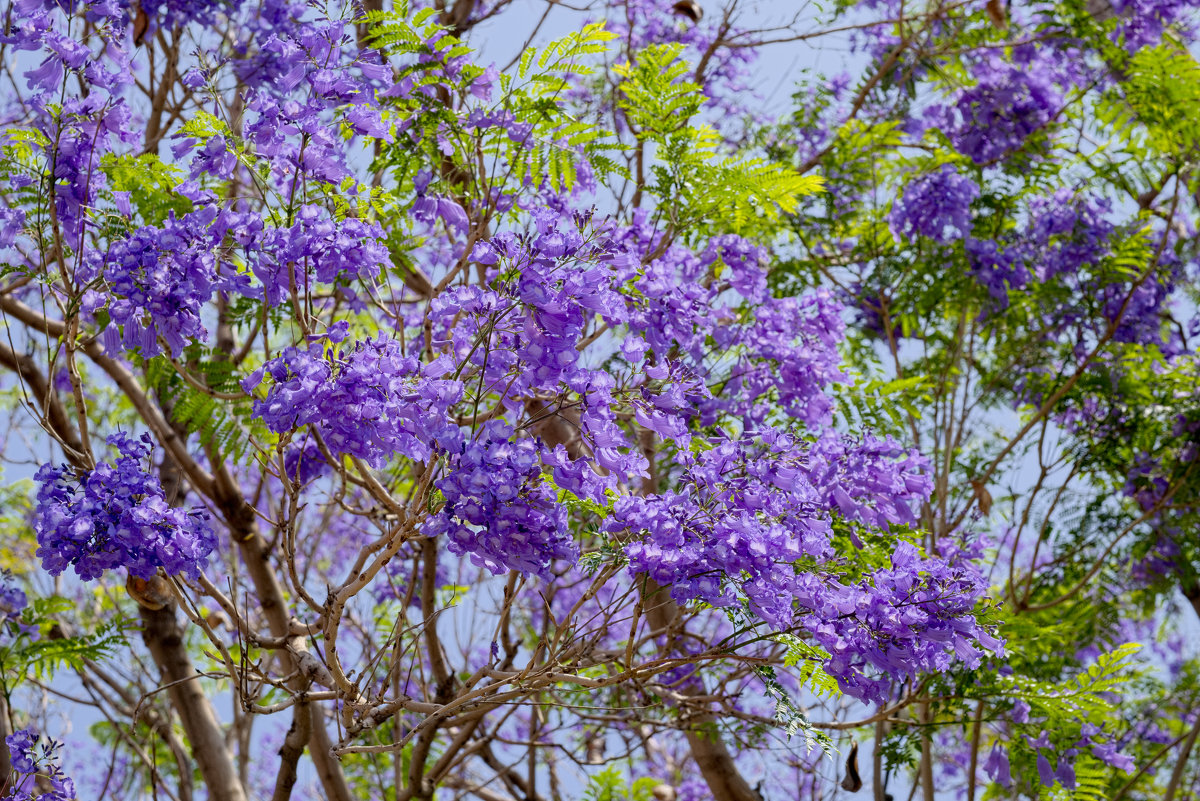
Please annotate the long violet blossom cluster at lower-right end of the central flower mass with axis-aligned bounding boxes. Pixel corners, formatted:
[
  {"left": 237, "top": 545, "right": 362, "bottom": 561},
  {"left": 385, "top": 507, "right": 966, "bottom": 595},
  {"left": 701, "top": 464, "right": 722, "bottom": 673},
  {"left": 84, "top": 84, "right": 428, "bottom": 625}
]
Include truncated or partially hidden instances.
[{"left": 604, "top": 429, "right": 1001, "bottom": 701}]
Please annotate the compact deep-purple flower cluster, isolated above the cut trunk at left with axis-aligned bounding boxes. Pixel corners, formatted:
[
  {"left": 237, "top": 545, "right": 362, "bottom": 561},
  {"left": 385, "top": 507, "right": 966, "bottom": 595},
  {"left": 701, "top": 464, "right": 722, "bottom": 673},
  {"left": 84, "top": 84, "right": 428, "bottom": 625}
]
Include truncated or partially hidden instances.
[{"left": 34, "top": 432, "right": 216, "bottom": 579}]
